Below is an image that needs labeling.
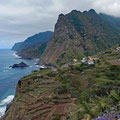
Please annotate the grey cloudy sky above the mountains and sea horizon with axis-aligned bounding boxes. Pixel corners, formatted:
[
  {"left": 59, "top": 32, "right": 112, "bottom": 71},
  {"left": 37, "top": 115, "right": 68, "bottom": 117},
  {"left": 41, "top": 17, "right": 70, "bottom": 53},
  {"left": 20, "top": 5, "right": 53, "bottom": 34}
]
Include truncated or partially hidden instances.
[{"left": 0, "top": 0, "right": 120, "bottom": 49}]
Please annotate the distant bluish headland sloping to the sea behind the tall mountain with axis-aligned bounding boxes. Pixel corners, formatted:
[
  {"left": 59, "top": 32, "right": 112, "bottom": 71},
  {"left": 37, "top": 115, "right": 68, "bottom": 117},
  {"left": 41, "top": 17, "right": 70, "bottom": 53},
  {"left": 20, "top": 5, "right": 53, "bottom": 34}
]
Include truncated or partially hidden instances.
[{"left": 12, "top": 31, "right": 53, "bottom": 58}]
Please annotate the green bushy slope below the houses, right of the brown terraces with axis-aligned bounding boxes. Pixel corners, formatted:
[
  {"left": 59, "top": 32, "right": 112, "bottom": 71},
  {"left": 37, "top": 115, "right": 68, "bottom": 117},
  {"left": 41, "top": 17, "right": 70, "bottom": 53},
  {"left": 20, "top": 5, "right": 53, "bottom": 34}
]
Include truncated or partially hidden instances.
[{"left": 56, "top": 60, "right": 120, "bottom": 119}]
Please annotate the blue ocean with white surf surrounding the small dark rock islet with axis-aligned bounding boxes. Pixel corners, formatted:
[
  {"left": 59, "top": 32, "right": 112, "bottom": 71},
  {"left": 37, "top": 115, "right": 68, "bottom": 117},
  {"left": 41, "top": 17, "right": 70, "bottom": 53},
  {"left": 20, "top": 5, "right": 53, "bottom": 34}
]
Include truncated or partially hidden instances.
[{"left": 0, "top": 50, "right": 38, "bottom": 117}]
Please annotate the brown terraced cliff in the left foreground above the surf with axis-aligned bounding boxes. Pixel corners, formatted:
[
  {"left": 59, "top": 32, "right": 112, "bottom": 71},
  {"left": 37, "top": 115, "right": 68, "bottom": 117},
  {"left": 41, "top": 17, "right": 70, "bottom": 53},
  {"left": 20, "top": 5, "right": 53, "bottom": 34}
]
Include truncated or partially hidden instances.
[{"left": 0, "top": 69, "right": 75, "bottom": 120}]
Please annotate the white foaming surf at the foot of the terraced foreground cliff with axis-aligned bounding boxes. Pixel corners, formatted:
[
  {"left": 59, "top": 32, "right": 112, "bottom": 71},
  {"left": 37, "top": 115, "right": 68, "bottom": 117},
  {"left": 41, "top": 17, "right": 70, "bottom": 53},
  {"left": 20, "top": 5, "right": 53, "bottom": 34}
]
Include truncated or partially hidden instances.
[{"left": 0, "top": 95, "right": 14, "bottom": 117}]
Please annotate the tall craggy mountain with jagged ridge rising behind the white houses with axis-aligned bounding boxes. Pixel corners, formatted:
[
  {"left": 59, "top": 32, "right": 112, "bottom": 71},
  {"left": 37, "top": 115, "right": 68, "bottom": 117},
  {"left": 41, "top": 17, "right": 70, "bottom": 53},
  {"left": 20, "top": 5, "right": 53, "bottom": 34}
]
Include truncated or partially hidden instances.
[{"left": 39, "top": 9, "right": 120, "bottom": 64}]
